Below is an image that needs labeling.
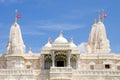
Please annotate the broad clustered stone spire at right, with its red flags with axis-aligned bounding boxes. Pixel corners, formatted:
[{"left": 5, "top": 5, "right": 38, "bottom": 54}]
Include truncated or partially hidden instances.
[{"left": 86, "top": 12, "right": 111, "bottom": 53}]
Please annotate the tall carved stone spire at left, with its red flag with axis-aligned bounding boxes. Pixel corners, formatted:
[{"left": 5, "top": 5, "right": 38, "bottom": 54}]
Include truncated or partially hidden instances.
[{"left": 7, "top": 11, "right": 25, "bottom": 54}]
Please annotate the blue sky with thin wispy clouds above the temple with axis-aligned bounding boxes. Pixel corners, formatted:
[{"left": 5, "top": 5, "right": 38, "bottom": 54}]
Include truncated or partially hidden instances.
[{"left": 0, "top": 0, "right": 120, "bottom": 54}]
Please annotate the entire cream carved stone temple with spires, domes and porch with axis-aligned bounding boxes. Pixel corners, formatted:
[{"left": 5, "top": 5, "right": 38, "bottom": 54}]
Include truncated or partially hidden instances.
[{"left": 0, "top": 17, "right": 120, "bottom": 80}]
